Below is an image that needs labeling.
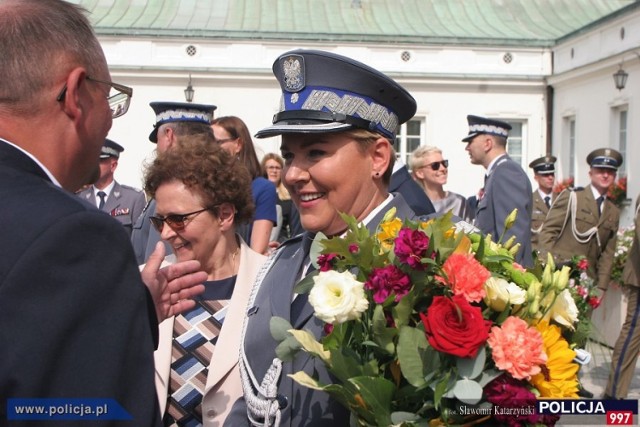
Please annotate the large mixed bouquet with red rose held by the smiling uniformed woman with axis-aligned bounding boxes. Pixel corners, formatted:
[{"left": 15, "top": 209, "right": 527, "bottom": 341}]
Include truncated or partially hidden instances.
[{"left": 271, "top": 211, "right": 579, "bottom": 426}]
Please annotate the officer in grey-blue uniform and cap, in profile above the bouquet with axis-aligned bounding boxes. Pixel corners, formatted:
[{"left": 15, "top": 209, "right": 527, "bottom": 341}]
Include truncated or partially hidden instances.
[{"left": 462, "top": 115, "right": 533, "bottom": 267}]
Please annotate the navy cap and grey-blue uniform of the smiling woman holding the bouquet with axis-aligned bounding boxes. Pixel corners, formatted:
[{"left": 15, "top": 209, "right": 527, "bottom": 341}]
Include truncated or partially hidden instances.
[{"left": 230, "top": 50, "right": 416, "bottom": 427}]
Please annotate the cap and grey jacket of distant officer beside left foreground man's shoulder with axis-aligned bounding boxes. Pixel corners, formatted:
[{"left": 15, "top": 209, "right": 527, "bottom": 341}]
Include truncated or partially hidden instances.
[{"left": 78, "top": 139, "right": 146, "bottom": 236}]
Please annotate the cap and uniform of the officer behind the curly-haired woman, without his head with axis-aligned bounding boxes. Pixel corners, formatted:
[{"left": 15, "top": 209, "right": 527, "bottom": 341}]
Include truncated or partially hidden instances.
[{"left": 131, "top": 102, "right": 217, "bottom": 264}]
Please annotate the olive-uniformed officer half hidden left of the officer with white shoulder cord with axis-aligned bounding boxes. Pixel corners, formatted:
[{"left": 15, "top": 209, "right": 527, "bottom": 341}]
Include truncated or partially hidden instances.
[{"left": 529, "top": 156, "right": 557, "bottom": 250}]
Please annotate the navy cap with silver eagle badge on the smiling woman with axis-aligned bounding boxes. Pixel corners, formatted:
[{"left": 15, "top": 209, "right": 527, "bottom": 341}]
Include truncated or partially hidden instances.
[{"left": 256, "top": 49, "right": 416, "bottom": 142}]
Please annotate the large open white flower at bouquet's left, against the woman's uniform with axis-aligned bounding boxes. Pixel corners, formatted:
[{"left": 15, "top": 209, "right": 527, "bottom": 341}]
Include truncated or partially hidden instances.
[{"left": 309, "top": 270, "right": 369, "bottom": 324}]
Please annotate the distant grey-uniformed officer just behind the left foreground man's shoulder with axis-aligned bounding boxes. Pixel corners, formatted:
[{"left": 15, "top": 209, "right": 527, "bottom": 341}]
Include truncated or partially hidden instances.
[{"left": 78, "top": 139, "right": 146, "bottom": 235}]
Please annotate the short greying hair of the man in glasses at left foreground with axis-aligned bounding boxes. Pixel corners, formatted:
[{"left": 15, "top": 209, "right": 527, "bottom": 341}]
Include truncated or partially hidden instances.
[{"left": 0, "top": 0, "right": 107, "bottom": 114}]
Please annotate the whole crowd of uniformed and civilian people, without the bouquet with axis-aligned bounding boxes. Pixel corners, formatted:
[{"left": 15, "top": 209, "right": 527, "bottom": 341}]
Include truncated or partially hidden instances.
[{"left": 0, "top": 0, "right": 640, "bottom": 427}]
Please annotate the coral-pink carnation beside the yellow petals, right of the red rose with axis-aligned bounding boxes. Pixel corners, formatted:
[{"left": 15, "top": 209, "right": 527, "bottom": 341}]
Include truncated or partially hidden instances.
[{"left": 487, "top": 316, "right": 547, "bottom": 380}]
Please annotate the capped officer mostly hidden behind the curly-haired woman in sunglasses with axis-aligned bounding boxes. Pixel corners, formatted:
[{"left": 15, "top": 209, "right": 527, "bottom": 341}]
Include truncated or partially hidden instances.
[{"left": 131, "top": 102, "right": 217, "bottom": 264}]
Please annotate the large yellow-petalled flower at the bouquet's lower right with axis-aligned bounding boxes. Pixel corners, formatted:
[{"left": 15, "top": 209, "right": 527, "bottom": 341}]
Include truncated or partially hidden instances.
[{"left": 530, "top": 321, "right": 579, "bottom": 399}]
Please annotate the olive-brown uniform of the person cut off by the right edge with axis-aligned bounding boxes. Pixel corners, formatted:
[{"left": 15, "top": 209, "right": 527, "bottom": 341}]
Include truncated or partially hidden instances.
[{"left": 605, "top": 198, "right": 640, "bottom": 399}]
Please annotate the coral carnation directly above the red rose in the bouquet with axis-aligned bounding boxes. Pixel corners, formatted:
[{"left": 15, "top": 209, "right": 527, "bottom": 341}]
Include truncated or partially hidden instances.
[{"left": 438, "top": 253, "right": 491, "bottom": 302}]
